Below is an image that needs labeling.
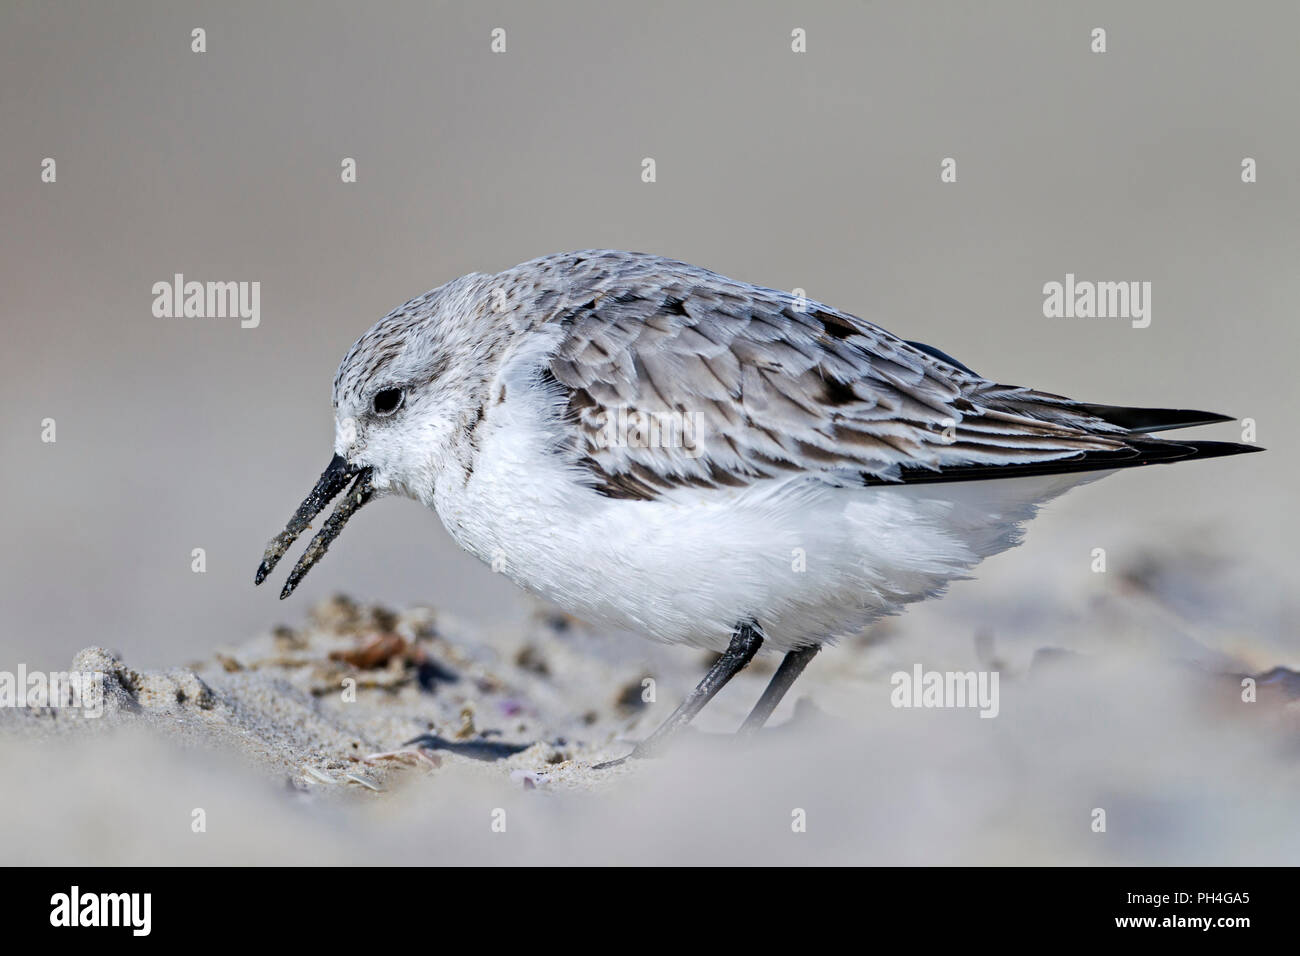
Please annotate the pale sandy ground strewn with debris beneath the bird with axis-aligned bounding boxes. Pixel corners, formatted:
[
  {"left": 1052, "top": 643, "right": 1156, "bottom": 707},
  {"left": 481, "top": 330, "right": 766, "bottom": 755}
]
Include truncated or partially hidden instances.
[{"left": 0, "top": 538, "right": 1300, "bottom": 865}]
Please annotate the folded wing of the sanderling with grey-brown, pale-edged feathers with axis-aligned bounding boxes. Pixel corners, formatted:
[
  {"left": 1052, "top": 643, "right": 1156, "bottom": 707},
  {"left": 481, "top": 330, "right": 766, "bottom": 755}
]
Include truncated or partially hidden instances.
[{"left": 533, "top": 254, "right": 1154, "bottom": 497}]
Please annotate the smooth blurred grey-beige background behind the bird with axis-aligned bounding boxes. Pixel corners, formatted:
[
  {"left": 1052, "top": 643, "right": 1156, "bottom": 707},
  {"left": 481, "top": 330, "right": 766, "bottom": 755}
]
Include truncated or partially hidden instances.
[{"left": 0, "top": 0, "right": 1300, "bottom": 669}]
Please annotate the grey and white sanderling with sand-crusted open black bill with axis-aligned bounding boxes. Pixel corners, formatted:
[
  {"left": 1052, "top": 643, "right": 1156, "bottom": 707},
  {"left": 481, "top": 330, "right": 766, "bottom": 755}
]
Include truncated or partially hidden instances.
[{"left": 256, "top": 250, "right": 1260, "bottom": 756}]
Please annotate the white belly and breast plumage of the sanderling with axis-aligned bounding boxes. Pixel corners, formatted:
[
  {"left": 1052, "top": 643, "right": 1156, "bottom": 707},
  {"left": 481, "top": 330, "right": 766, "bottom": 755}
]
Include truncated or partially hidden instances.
[{"left": 430, "top": 395, "right": 1097, "bottom": 649}]
